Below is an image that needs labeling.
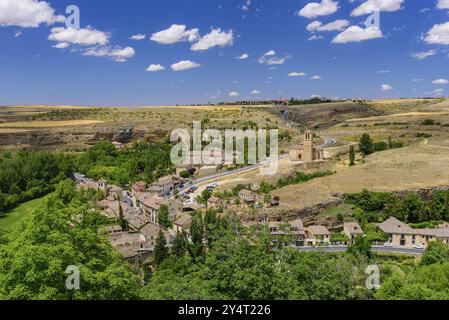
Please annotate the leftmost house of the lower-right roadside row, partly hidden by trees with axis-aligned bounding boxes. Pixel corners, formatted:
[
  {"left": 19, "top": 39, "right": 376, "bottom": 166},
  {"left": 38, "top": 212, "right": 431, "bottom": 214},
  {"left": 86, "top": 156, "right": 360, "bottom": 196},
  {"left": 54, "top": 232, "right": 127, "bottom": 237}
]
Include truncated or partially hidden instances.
[{"left": 268, "top": 219, "right": 306, "bottom": 247}]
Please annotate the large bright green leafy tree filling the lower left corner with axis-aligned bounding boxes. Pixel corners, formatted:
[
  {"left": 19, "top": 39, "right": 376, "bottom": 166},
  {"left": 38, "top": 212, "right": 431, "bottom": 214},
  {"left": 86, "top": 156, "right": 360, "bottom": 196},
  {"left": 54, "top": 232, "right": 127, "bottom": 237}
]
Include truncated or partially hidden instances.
[{"left": 0, "top": 184, "right": 139, "bottom": 300}]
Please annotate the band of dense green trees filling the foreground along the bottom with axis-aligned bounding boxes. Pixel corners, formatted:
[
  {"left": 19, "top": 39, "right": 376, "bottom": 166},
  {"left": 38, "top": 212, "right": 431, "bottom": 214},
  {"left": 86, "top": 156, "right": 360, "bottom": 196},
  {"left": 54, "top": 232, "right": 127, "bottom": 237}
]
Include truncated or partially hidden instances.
[{"left": 0, "top": 180, "right": 449, "bottom": 300}]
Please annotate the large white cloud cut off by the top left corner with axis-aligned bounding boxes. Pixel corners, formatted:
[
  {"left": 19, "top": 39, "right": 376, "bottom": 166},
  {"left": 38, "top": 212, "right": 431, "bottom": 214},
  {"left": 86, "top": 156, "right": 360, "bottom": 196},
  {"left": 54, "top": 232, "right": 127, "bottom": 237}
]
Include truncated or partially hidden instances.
[{"left": 0, "top": 0, "right": 65, "bottom": 28}]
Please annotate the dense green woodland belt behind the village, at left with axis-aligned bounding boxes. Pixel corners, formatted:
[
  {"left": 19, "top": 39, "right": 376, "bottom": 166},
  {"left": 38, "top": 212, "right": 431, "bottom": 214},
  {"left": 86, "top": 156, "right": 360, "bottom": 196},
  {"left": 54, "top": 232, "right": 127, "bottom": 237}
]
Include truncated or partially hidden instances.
[{"left": 0, "top": 141, "right": 174, "bottom": 215}]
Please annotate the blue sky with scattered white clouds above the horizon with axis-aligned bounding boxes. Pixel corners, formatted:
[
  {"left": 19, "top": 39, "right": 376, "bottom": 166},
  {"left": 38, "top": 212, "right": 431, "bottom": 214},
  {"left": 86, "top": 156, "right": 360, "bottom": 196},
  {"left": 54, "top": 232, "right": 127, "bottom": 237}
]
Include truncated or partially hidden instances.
[{"left": 0, "top": 0, "right": 449, "bottom": 106}]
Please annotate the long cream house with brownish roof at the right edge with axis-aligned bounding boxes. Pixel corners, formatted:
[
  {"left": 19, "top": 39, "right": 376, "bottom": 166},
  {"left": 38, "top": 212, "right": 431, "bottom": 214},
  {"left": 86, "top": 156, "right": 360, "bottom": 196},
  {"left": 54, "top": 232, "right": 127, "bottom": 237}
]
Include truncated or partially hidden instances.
[{"left": 379, "top": 217, "right": 449, "bottom": 247}]
